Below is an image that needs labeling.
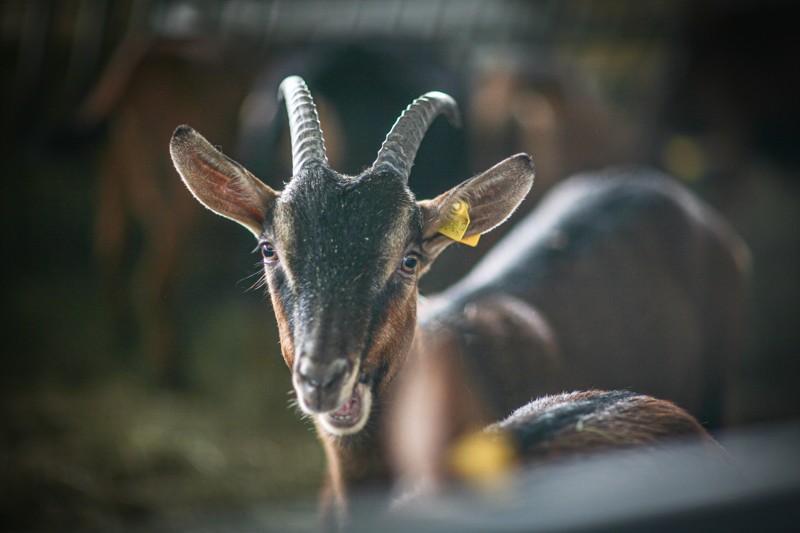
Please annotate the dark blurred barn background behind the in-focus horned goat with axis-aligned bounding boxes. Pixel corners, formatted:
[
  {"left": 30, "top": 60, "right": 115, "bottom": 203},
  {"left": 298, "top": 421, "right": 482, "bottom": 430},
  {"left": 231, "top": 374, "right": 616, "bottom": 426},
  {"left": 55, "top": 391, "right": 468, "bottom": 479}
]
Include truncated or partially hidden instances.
[{"left": 0, "top": 0, "right": 800, "bottom": 530}]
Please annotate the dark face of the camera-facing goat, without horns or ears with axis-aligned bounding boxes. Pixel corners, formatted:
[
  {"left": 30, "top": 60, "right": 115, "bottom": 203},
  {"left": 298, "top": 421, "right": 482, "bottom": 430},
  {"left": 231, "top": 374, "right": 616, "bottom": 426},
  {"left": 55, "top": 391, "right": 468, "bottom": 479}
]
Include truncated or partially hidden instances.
[{"left": 260, "top": 165, "right": 423, "bottom": 435}]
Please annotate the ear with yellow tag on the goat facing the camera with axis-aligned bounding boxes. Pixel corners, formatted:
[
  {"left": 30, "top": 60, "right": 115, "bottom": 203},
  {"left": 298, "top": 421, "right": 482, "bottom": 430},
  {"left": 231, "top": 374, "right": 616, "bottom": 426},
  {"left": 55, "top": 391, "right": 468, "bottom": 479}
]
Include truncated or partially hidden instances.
[{"left": 420, "top": 154, "right": 534, "bottom": 257}]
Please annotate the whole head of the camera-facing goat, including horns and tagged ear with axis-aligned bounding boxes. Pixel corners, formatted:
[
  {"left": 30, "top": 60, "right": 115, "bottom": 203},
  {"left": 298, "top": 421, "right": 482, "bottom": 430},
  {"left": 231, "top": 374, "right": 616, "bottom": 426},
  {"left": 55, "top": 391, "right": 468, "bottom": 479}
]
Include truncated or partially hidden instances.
[{"left": 170, "top": 77, "right": 533, "bottom": 436}]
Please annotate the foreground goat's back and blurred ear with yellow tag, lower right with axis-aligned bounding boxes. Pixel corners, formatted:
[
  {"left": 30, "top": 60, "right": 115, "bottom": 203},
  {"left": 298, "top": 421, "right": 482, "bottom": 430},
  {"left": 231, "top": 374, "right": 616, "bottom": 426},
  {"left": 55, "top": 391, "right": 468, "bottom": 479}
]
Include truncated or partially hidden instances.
[{"left": 385, "top": 336, "right": 729, "bottom": 494}]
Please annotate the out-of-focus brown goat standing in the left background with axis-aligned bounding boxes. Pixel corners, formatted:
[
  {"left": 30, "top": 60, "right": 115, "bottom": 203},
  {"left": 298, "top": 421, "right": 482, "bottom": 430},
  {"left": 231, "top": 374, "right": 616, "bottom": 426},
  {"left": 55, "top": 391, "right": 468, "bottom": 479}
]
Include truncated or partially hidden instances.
[{"left": 84, "top": 40, "right": 253, "bottom": 384}]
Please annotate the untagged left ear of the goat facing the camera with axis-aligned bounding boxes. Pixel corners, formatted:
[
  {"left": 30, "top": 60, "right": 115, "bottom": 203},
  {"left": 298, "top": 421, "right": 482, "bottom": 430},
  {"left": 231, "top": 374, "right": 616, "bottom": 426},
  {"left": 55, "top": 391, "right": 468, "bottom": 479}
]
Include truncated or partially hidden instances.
[{"left": 169, "top": 126, "right": 279, "bottom": 238}]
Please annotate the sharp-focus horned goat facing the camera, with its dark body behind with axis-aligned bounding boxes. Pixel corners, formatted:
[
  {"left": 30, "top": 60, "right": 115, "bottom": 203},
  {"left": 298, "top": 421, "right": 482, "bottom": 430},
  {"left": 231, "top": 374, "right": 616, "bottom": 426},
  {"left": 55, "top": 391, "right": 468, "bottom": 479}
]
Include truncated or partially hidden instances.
[{"left": 170, "top": 76, "right": 752, "bottom": 512}]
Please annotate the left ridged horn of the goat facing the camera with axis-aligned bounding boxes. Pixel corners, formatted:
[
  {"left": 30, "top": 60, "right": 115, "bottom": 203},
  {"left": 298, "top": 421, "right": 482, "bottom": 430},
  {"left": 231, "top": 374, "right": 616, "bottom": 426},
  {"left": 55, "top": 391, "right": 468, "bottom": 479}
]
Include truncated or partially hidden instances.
[{"left": 278, "top": 76, "right": 328, "bottom": 175}]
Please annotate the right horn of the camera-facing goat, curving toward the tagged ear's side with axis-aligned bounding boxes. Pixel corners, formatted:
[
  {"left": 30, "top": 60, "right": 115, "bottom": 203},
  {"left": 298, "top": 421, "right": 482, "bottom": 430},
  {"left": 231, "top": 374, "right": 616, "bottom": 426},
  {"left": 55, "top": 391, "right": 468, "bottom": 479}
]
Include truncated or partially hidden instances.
[{"left": 372, "top": 91, "right": 461, "bottom": 181}]
